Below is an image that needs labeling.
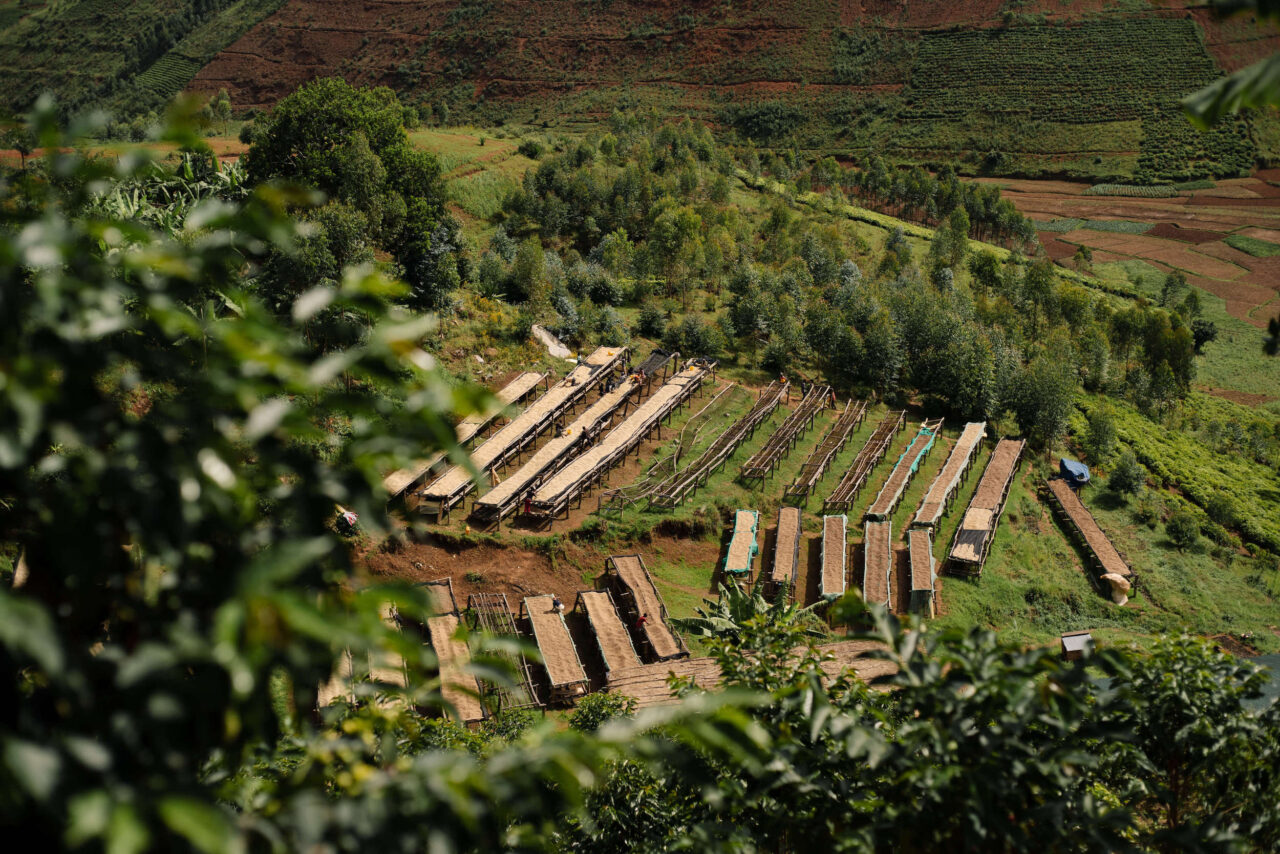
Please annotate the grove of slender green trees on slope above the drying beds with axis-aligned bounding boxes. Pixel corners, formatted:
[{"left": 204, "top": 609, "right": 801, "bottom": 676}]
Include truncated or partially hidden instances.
[{"left": 481, "top": 117, "right": 1194, "bottom": 442}]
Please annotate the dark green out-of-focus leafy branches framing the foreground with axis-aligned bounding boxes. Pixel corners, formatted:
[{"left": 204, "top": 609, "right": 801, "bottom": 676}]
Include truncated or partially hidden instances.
[{"left": 0, "top": 109, "right": 1280, "bottom": 853}]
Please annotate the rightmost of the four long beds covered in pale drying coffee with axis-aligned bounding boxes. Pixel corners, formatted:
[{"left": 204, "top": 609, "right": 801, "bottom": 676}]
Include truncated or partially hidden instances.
[{"left": 532, "top": 361, "right": 714, "bottom": 524}]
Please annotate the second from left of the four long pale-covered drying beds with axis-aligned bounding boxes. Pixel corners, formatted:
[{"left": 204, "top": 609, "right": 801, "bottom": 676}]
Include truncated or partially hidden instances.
[{"left": 419, "top": 347, "right": 627, "bottom": 517}]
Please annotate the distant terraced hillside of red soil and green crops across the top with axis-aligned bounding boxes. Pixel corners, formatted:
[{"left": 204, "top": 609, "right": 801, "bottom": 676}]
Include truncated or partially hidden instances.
[{"left": 0, "top": 0, "right": 1280, "bottom": 179}]
